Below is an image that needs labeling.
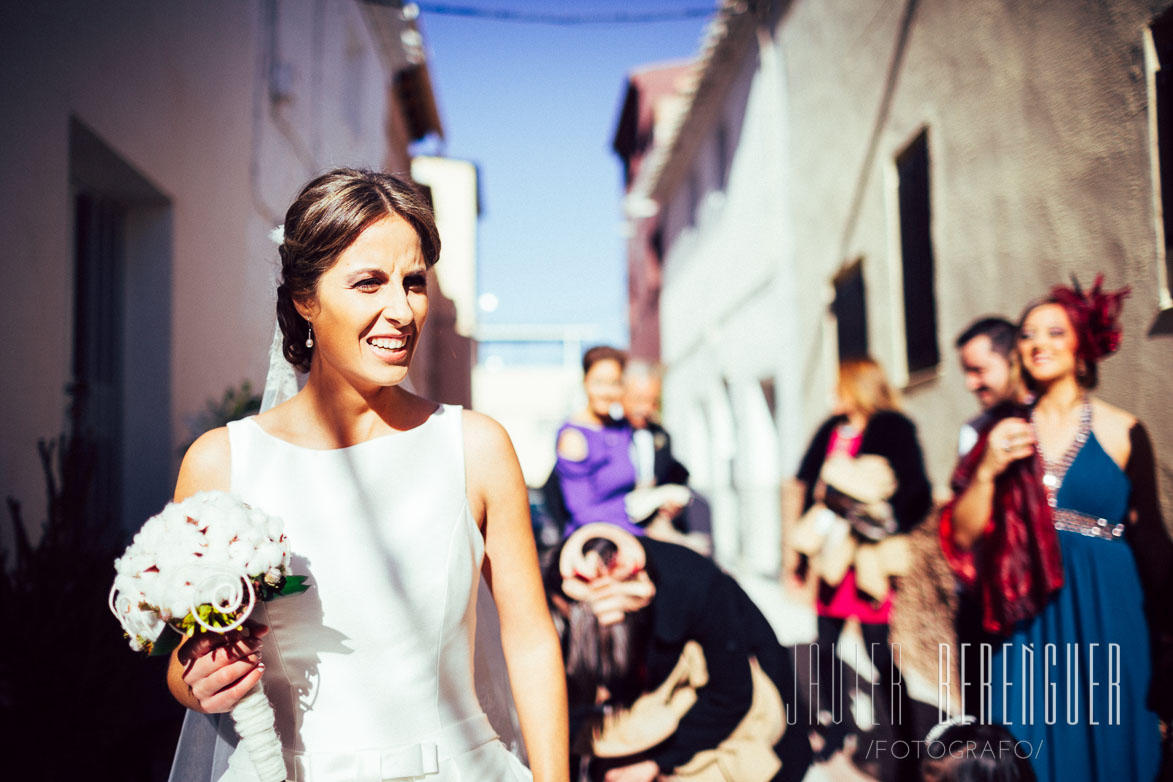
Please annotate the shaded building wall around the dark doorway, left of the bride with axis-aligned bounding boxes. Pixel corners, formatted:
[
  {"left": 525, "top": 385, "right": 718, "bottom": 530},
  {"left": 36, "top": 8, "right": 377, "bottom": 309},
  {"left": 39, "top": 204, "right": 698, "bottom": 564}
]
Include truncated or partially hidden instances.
[{"left": 0, "top": 0, "right": 431, "bottom": 533}]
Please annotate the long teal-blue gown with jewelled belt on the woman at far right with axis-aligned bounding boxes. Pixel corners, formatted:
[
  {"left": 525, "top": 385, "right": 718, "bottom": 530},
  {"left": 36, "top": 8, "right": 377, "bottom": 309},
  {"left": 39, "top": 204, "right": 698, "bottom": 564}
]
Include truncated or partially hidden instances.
[{"left": 983, "top": 434, "right": 1160, "bottom": 782}]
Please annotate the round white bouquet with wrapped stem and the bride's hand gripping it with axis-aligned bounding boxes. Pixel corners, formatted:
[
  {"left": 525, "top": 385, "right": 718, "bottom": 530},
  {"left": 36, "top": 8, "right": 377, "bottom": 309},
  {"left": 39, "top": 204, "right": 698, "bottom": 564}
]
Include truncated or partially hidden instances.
[{"left": 109, "top": 491, "right": 306, "bottom": 782}]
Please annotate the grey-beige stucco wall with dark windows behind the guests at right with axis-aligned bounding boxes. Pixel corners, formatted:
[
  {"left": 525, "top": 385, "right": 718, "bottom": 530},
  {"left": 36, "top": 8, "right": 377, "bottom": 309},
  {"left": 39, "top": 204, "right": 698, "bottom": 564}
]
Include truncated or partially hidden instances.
[{"left": 779, "top": 0, "right": 1173, "bottom": 513}]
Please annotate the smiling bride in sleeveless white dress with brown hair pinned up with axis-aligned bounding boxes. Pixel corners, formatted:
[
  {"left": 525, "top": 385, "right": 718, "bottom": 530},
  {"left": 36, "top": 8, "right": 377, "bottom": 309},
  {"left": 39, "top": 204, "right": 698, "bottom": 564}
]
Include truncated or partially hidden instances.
[{"left": 168, "top": 169, "right": 569, "bottom": 782}]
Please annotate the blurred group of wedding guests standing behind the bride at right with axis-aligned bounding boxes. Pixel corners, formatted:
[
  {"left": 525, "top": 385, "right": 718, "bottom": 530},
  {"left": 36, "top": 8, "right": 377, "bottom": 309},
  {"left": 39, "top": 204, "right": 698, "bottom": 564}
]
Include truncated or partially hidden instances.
[{"left": 536, "top": 279, "right": 1173, "bottom": 782}]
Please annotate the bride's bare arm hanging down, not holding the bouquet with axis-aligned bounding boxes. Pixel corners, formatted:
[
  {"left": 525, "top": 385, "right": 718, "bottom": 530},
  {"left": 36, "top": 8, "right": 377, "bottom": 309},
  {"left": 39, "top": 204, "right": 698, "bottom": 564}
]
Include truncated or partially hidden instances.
[{"left": 463, "top": 412, "right": 570, "bottom": 782}]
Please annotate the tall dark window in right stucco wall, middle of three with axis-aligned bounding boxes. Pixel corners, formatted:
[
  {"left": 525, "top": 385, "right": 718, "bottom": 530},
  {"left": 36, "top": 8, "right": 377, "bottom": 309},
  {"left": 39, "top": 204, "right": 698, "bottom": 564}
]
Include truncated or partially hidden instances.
[{"left": 896, "top": 131, "right": 941, "bottom": 374}]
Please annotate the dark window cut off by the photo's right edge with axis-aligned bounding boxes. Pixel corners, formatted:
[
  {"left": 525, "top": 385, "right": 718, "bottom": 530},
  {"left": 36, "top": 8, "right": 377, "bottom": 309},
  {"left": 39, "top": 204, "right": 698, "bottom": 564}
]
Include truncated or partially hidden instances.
[{"left": 1148, "top": 12, "right": 1173, "bottom": 307}]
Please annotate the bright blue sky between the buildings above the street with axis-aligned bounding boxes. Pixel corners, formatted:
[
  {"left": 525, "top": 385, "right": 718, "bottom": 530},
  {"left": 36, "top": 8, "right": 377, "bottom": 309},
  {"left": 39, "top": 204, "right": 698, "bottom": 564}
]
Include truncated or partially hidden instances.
[{"left": 420, "top": 0, "right": 711, "bottom": 354}]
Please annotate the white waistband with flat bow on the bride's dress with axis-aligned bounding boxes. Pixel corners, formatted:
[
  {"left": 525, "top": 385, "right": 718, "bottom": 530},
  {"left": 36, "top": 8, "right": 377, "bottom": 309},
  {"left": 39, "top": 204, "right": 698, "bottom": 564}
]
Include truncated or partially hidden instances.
[{"left": 282, "top": 714, "right": 497, "bottom": 782}]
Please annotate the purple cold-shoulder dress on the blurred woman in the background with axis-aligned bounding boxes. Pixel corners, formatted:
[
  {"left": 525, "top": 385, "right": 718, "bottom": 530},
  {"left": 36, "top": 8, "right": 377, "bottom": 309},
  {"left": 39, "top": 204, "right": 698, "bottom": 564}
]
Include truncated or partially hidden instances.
[{"left": 554, "top": 421, "right": 644, "bottom": 535}]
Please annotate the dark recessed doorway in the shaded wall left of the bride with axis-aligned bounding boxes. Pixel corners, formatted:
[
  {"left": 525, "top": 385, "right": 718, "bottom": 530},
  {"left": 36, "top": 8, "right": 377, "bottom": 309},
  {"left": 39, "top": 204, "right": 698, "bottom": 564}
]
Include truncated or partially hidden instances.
[{"left": 69, "top": 120, "right": 175, "bottom": 525}]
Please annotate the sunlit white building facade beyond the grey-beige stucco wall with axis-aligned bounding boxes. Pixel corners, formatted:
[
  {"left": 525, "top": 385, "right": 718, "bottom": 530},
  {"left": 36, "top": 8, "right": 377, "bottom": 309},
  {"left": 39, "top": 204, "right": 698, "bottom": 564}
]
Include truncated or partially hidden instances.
[{"left": 660, "top": 48, "right": 793, "bottom": 573}]
